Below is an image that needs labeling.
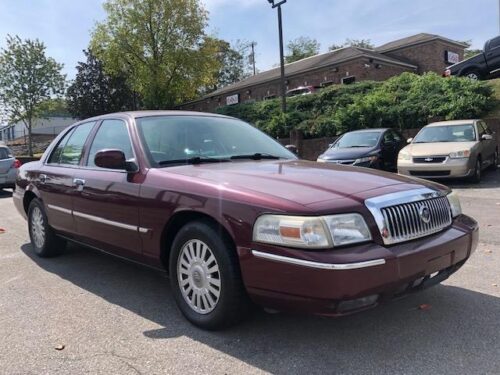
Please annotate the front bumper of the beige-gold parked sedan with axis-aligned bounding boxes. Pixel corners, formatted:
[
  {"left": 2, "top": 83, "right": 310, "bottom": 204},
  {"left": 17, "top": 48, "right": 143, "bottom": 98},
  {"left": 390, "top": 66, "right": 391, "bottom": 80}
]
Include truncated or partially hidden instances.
[{"left": 398, "top": 158, "right": 474, "bottom": 178}]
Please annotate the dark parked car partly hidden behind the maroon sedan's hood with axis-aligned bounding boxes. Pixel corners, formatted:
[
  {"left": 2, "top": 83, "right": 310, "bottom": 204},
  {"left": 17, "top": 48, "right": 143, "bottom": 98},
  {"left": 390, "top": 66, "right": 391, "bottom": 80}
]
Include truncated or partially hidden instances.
[{"left": 317, "top": 129, "right": 406, "bottom": 170}]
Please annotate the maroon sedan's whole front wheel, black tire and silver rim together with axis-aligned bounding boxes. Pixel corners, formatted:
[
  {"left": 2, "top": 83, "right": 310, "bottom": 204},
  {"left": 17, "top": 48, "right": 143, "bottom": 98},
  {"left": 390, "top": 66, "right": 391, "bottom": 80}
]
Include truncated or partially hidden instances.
[{"left": 169, "top": 221, "right": 251, "bottom": 330}]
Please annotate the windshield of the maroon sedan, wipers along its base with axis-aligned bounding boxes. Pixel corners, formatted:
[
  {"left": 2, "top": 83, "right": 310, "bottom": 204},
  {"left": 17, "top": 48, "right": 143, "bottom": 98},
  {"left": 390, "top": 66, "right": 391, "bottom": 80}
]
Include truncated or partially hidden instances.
[{"left": 137, "top": 116, "right": 296, "bottom": 166}]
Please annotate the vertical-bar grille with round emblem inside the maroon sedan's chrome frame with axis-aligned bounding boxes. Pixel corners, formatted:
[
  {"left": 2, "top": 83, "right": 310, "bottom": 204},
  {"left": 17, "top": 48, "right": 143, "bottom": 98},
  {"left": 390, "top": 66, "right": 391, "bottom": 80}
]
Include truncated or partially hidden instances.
[{"left": 381, "top": 197, "right": 452, "bottom": 243}]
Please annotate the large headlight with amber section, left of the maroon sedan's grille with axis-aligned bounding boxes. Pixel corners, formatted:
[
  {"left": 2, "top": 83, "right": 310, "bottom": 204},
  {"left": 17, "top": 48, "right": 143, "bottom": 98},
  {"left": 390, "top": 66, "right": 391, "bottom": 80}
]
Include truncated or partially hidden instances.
[{"left": 253, "top": 214, "right": 372, "bottom": 249}]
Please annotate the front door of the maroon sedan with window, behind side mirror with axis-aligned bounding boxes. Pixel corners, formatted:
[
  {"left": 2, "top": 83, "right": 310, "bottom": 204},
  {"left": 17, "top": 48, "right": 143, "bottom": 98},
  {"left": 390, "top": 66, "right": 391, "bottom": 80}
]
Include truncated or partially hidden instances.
[{"left": 73, "top": 119, "right": 142, "bottom": 257}]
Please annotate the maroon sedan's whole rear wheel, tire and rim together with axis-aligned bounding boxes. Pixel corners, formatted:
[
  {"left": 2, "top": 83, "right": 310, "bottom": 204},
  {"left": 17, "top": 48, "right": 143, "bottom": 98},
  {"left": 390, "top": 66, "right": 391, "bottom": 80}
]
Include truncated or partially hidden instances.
[{"left": 28, "top": 198, "right": 66, "bottom": 258}]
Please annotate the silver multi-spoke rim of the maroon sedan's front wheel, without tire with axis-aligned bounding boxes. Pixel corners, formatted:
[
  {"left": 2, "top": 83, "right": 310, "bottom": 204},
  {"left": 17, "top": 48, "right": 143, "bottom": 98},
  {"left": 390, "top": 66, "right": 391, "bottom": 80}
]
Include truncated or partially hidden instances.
[{"left": 177, "top": 240, "right": 221, "bottom": 314}]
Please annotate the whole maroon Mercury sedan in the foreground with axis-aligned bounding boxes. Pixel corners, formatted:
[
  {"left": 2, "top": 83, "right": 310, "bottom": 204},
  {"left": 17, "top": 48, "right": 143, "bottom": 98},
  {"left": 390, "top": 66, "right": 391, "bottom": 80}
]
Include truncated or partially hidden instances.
[{"left": 14, "top": 112, "right": 478, "bottom": 329}]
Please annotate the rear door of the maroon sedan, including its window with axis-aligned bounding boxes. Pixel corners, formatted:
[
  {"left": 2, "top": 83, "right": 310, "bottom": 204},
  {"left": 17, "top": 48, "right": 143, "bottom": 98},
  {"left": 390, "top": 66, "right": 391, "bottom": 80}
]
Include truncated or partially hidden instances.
[{"left": 36, "top": 122, "right": 95, "bottom": 234}]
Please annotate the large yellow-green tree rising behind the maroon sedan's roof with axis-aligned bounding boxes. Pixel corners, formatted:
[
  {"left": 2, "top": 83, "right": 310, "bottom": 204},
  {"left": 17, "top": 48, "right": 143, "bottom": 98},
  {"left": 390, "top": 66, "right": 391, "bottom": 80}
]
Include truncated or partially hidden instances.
[{"left": 91, "top": 0, "right": 218, "bottom": 109}]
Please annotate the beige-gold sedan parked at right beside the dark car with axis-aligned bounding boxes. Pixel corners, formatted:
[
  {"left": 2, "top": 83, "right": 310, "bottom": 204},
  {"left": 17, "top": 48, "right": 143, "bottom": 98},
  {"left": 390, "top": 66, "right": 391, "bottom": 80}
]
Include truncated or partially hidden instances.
[{"left": 398, "top": 120, "right": 498, "bottom": 182}]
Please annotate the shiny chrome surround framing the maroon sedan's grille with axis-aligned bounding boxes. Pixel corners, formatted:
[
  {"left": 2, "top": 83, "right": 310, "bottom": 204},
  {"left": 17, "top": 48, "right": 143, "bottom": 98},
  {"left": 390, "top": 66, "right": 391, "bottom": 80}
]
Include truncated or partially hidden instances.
[{"left": 365, "top": 188, "right": 451, "bottom": 245}]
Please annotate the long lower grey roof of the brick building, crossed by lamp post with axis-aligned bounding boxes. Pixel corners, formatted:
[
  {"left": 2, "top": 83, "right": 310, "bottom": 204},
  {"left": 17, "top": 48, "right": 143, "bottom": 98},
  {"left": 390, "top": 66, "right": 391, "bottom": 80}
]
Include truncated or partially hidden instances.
[{"left": 206, "top": 47, "right": 417, "bottom": 97}]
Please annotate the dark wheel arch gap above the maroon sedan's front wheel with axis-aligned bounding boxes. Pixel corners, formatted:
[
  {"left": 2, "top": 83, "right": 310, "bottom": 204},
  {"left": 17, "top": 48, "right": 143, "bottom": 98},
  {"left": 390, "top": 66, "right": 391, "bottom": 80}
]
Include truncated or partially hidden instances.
[{"left": 160, "top": 210, "right": 236, "bottom": 272}]
